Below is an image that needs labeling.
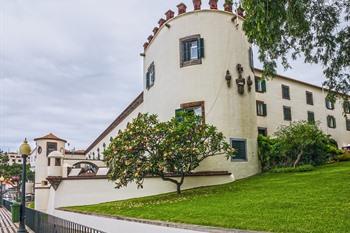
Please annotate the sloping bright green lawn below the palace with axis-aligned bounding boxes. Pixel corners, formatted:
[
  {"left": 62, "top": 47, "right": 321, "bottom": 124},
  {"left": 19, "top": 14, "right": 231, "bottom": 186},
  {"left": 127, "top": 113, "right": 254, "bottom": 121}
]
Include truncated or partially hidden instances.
[{"left": 63, "top": 162, "right": 350, "bottom": 233}]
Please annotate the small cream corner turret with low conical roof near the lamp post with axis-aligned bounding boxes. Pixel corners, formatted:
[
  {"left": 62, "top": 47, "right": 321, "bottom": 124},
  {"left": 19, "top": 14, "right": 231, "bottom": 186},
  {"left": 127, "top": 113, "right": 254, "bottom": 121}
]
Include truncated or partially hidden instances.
[{"left": 34, "top": 133, "right": 66, "bottom": 211}]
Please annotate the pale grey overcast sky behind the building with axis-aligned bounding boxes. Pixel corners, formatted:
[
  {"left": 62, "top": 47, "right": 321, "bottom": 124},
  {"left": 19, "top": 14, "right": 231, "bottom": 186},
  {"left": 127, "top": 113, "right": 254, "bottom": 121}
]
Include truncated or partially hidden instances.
[{"left": 0, "top": 0, "right": 323, "bottom": 151}]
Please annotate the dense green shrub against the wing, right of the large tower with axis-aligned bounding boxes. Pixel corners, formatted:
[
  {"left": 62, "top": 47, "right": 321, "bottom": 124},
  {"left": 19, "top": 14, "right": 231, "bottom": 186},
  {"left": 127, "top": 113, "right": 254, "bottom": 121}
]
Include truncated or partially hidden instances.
[{"left": 258, "top": 121, "right": 340, "bottom": 171}]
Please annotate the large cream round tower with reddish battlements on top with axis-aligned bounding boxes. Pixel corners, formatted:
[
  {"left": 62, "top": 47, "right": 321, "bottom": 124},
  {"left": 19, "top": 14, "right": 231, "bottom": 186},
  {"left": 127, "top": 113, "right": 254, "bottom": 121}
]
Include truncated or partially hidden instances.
[{"left": 142, "top": 1, "right": 259, "bottom": 178}]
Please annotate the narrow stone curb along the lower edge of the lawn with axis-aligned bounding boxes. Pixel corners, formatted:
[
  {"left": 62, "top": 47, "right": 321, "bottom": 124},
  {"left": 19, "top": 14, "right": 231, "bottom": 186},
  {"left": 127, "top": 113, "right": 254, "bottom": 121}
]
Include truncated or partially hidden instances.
[{"left": 57, "top": 208, "right": 268, "bottom": 233}]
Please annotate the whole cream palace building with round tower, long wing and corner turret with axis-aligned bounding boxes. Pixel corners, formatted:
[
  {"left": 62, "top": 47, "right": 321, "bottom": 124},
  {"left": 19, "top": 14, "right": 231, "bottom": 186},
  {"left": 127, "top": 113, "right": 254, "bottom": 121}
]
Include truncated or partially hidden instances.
[{"left": 35, "top": 0, "right": 350, "bottom": 212}]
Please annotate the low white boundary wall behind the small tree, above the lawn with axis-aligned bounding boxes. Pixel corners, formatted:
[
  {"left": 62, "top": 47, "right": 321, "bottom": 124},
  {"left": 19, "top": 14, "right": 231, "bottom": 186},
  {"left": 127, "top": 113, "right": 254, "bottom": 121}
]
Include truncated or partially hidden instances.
[{"left": 48, "top": 176, "right": 234, "bottom": 212}]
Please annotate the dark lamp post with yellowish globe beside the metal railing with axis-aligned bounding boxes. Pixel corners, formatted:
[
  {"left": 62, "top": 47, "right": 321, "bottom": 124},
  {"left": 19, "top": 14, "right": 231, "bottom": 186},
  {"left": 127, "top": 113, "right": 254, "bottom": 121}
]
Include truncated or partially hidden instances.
[{"left": 17, "top": 139, "right": 32, "bottom": 233}]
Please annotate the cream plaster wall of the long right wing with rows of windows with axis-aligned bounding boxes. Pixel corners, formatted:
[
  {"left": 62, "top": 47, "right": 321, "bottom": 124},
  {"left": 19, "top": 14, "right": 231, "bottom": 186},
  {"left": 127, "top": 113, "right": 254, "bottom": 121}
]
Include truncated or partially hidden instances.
[{"left": 256, "top": 72, "right": 350, "bottom": 147}]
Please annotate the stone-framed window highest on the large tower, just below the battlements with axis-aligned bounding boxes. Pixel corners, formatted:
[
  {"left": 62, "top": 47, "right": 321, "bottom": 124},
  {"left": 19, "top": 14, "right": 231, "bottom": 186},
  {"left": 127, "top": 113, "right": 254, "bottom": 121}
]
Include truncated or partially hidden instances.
[{"left": 180, "top": 35, "right": 204, "bottom": 67}]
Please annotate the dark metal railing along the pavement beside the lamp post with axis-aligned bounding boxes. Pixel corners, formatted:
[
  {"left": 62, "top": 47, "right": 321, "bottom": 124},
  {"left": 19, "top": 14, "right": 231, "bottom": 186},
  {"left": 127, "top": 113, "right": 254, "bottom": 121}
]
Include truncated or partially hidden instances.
[{"left": 3, "top": 200, "right": 105, "bottom": 233}]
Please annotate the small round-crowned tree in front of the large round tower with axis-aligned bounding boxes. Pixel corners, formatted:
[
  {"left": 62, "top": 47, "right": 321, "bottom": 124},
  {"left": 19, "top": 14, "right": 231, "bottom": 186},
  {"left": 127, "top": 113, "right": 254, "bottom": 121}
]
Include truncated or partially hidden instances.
[{"left": 104, "top": 112, "right": 234, "bottom": 194}]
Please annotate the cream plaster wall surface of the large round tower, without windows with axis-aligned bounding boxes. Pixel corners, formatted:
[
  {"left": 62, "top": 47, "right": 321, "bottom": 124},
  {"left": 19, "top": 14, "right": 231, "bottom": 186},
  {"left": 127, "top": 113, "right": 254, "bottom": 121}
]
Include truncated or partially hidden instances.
[{"left": 144, "top": 10, "right": 259, "bottom": 178}]
